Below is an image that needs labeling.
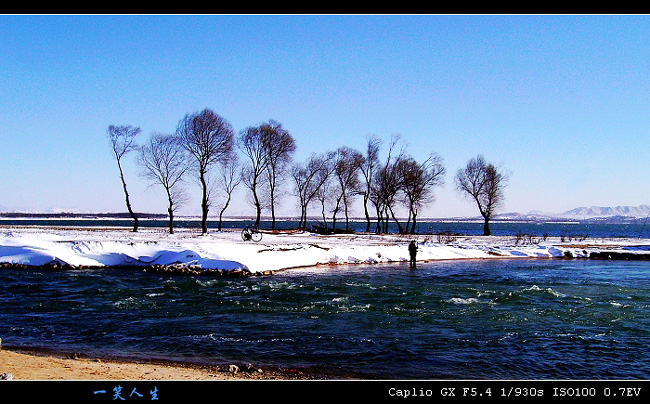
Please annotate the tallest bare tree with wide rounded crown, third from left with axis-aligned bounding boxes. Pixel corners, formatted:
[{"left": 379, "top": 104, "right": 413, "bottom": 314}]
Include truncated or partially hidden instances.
[{"left": 176, "top": 109, "right": 234, "bottom": 234}]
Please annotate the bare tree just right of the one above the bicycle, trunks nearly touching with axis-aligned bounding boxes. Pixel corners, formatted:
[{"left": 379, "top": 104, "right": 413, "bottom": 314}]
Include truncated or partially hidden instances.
[{"left": 260, "top": 120, "right": 296, "bottom": 229}]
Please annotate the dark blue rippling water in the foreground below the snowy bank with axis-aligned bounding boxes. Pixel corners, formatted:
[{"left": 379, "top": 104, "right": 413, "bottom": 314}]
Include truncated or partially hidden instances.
[{"left": 0, "top": 259, "right": 650, "bottom": 379}]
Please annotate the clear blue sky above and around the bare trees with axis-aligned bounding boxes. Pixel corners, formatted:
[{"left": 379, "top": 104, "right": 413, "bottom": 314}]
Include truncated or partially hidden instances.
[{"left": 0, "top": 15, "right": 650, "bottom": 217}]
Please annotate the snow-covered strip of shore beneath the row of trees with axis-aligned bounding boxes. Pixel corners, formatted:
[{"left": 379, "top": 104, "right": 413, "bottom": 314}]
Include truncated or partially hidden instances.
[{"left": 0, "top": 226, "right": 650, "bottom": 274}]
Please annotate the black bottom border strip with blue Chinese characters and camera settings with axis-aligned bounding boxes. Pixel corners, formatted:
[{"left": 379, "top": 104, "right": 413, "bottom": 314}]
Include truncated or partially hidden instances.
[{"left": 0, "top": 380, "right": 650, "bottom": 403}]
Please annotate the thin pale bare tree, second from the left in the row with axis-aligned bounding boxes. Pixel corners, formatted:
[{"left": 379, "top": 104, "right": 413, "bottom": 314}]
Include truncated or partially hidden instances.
[{"left": 138, "top": 133, "right": 189, "bottom": 234}]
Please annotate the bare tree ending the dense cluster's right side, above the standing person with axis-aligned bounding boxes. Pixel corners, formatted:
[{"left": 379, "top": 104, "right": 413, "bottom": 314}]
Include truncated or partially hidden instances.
[{"left": 398, "top": 153, "right": 446, "bottom": 234}]
